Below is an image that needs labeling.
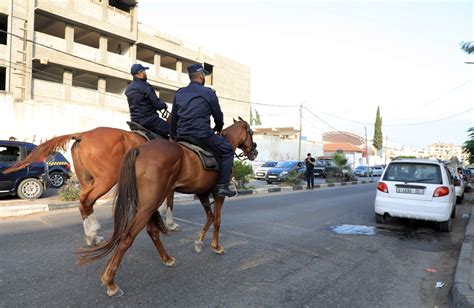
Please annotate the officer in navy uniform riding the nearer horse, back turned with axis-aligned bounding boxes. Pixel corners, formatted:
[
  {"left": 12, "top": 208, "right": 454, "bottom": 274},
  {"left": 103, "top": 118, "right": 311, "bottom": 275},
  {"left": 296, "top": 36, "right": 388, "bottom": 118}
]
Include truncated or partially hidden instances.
[{"left": 170, "top": 64, "right": 235, "bottom": 197}]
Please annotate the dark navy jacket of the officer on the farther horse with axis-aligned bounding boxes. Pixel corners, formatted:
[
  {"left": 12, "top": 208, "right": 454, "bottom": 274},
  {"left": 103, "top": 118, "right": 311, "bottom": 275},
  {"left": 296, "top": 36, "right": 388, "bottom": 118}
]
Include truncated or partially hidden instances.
[{"left": 125, "top": 77, "right": 168, "bottom": 125}]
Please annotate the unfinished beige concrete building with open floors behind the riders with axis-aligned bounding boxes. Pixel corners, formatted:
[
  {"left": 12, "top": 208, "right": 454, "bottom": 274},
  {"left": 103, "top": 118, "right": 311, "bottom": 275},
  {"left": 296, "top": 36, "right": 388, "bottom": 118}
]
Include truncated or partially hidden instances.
[{"left": 0, "top": 0, "right": 250, "bottom": 142}]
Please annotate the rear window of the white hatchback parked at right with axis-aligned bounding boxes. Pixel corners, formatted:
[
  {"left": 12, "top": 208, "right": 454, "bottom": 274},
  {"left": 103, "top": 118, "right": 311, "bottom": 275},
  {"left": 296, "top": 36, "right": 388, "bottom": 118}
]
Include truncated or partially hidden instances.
[{"left": 383, "top": 163, "right": 443, "bottom": 184}]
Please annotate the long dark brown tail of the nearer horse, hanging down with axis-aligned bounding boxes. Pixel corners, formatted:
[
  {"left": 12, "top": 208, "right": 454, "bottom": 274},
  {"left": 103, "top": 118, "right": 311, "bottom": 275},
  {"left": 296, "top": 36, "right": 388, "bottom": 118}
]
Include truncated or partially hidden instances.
[{"left": 79, "top": 148, "right": 167, "bottom": 265}]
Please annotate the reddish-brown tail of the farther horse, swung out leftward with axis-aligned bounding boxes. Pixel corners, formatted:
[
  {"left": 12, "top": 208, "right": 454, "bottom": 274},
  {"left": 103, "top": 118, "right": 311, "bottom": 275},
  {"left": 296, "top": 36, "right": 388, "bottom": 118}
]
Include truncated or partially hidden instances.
[{"left": 3, "top": 133, "right": 83, "bottom": 174}]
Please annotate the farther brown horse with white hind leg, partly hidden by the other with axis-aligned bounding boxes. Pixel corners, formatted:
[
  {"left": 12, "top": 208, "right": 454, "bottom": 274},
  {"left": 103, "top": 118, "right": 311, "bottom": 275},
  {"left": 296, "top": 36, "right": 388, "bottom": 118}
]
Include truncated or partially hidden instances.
[{"left": 5, "top": 127, "right": 179, "bottom": 245}]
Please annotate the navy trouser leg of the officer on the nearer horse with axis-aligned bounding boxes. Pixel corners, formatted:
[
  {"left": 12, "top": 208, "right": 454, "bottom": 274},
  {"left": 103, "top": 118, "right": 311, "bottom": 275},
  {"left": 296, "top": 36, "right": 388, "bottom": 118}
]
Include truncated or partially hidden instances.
[{"left": 199, "top": 135, "right": 234, "bottom": 184}]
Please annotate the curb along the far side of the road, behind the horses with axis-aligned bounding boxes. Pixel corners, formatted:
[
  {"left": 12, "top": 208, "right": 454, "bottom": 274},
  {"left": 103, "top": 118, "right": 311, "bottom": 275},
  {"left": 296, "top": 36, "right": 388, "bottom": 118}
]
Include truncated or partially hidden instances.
[{"left": 0, "top": 180, "right": 376, "bottom": 218}]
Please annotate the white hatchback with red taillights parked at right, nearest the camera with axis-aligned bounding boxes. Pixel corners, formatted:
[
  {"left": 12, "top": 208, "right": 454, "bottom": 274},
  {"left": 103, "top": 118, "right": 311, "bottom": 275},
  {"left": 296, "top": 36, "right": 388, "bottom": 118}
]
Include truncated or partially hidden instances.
[{"left": 374, "top": 159, "right": 456, "bottom": 232}]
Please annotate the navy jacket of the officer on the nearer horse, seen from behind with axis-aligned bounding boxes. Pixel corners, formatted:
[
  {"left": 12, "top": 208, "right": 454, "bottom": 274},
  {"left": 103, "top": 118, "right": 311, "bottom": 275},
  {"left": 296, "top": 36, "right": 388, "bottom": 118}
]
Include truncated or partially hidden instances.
[{"left": 170, "top": 81, "right": 224, "bottom": 138}]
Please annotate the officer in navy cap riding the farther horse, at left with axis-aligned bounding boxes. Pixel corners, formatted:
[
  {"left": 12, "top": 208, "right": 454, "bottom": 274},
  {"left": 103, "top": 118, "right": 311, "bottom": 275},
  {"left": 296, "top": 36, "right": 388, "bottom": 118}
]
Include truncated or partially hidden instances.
[{"left": 125, "top": 64, "right": 169, "bottom": 139}]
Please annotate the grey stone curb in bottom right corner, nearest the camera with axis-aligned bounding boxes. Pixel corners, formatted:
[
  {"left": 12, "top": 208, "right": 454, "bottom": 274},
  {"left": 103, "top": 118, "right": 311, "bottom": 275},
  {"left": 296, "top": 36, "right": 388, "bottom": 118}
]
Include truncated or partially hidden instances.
[{"left": 453, "top": 201, "right": 474, "bottom": 307}]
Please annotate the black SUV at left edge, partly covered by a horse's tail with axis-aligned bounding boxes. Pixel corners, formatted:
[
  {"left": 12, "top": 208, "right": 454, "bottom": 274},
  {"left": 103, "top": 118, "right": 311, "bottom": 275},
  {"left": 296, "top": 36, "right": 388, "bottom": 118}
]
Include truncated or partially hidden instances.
[{"left": 0, "top": 140, "right": 50, "bottom": 199}]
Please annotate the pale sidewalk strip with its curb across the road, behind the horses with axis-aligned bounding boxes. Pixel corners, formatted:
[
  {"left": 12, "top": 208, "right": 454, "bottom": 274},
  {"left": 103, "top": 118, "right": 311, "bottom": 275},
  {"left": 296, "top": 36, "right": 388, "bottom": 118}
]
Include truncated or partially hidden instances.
[{"left": 0, "top": 180, "right": 376, "bottom": 218}]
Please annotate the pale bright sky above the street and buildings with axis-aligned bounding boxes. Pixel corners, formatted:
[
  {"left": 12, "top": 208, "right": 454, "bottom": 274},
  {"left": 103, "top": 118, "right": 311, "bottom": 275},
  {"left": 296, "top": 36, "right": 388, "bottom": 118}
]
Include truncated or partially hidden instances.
[{"left": 138, "top": 0, "right": 474, "bottom": 148}]
